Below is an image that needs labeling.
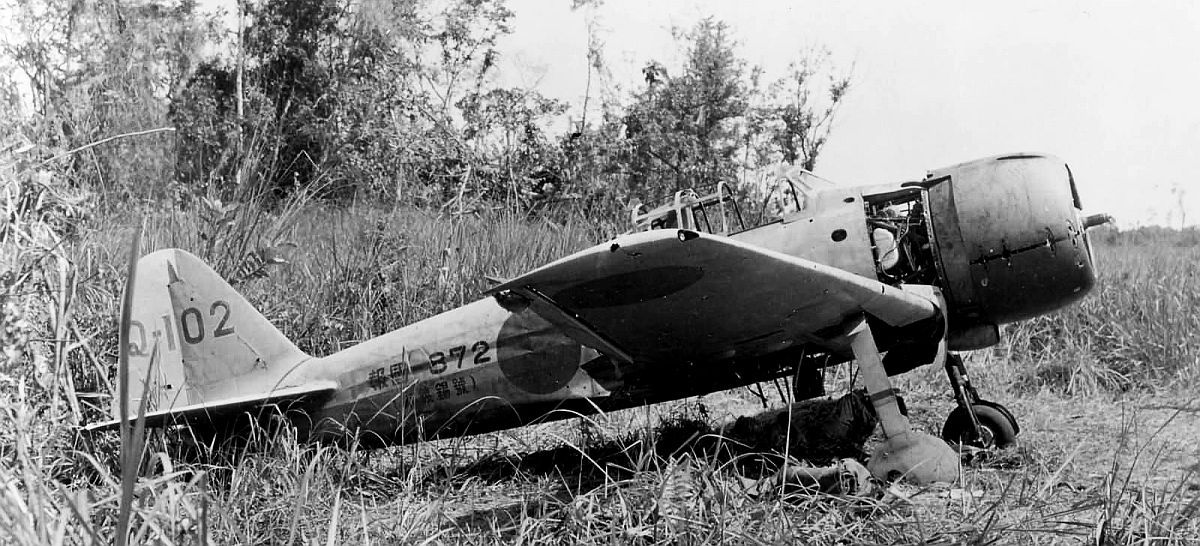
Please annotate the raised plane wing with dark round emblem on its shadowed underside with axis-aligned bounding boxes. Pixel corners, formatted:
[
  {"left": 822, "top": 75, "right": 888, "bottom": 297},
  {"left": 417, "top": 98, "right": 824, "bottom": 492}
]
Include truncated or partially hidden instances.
[{"left": 488, "top": 229, "right": 937, "bottom": 362}]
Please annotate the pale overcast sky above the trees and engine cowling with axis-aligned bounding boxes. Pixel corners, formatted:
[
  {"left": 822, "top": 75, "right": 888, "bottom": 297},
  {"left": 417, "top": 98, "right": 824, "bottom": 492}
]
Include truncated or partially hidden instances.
[{"left": 502, "top": 0, "right": 1200, "bottom": 227}]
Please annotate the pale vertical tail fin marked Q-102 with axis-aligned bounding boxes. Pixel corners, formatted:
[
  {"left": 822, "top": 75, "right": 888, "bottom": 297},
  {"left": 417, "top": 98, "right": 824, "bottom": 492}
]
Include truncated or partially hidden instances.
[{"left": 113, "top": 250, "right": 310, "bottom": 413}]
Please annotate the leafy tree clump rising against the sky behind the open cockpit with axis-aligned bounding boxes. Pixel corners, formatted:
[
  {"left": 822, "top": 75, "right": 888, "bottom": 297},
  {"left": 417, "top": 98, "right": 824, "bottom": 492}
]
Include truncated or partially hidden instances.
[{"left": 563, "top": 18, "right": 850, "bottom": 219}]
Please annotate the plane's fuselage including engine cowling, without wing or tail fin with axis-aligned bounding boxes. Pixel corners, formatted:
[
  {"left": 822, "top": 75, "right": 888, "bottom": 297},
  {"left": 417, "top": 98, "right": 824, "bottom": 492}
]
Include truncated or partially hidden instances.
[{"left": 298, "top": 156, "right": 1094, "bottom": 443}]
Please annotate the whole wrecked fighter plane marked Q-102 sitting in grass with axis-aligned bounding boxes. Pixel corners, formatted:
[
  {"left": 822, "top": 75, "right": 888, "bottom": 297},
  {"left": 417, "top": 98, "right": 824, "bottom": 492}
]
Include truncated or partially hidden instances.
[{"left": 89, "top": 154, "right": 1109, "bottom": 482}]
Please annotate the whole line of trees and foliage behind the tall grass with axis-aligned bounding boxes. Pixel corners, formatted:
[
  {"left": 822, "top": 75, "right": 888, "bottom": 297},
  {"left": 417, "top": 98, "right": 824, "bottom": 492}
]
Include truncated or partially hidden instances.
[{"left": 5, "top": 0, "right": 850, "bottom": 219}]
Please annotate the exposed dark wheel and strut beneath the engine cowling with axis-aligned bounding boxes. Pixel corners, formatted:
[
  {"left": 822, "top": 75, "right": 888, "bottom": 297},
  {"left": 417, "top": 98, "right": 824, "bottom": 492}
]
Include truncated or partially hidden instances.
[{"left": 942, "top": 354, "right": 1021, "bottom": 448}]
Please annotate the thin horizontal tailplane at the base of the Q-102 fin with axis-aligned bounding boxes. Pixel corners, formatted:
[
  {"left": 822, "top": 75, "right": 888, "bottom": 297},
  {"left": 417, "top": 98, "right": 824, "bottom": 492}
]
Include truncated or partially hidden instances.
[{"left": 84, "top": 382, "right": 337, "bottom": 431}]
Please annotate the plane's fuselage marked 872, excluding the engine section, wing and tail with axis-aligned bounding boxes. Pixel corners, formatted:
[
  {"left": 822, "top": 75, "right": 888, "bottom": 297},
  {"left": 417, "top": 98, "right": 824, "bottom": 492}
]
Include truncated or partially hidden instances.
[{"left": 304, "top": 188, "right": 892, "bottom": 444}]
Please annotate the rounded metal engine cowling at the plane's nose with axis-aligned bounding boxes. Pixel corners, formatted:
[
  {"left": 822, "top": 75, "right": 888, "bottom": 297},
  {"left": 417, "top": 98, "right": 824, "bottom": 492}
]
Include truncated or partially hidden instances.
[{"left": 919, "top": 154, "right": 1097, "bottom": 350}]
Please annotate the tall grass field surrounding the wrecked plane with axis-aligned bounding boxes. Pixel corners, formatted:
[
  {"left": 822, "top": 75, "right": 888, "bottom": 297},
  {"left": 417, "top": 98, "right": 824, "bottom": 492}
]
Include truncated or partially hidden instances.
[{"left": 0, "top": 188, "right": 1200, "bottom": 544}]
